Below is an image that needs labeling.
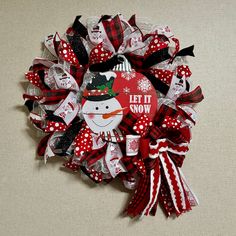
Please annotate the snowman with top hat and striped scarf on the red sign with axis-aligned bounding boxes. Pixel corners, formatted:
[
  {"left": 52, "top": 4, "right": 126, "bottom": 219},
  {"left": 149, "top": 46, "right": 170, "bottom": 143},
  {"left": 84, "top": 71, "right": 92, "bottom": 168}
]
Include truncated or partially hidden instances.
[{"left": 82, "top": 71, "right": 126, "bottom": 141}]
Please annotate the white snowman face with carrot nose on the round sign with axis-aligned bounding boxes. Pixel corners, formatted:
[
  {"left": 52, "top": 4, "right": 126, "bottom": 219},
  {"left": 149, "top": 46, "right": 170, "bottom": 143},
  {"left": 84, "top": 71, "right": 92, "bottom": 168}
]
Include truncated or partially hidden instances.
[{"left": 82, "top": 98, "right": 123, "bottom": 133}]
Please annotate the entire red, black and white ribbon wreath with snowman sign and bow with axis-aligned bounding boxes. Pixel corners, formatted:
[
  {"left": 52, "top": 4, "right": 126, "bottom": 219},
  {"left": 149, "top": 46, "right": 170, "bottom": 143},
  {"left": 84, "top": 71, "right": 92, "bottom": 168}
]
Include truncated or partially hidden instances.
[{"left": 23, "top": 14, "right": 203, "bottom": 217}]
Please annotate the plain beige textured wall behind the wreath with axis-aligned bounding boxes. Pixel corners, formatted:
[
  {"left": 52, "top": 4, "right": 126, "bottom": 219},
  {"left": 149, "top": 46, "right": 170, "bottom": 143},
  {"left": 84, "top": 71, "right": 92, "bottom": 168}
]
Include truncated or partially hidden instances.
[{"left": 0, "top": 0, "right": 236, "bottom": 236}]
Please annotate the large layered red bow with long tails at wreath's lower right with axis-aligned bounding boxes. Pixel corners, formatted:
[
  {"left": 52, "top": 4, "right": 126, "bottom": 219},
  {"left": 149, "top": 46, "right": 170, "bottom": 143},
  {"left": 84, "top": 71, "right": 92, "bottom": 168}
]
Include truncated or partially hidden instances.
[{"left": 119, "top": 104, "right": 197, "bottom": 216}]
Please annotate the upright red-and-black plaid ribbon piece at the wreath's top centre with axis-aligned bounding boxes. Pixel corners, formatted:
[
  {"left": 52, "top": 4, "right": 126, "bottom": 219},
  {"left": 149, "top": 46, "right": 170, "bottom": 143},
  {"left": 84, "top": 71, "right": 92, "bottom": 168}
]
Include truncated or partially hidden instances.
[{"left": 102, "top": 15, "right": 124, "bottom": 51}]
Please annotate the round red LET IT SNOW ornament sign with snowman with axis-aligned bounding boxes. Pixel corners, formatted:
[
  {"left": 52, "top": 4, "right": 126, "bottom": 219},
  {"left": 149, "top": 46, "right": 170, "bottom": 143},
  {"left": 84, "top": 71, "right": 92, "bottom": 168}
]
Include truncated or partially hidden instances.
[{"left": 82, "top": 71, "right": 157, "bottom": 142}]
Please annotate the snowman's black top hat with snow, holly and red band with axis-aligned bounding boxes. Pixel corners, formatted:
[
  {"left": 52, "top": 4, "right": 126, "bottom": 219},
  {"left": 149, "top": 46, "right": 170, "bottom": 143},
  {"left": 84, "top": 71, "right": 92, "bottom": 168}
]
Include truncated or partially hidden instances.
[{"left": 83, "top": 71, "right": 119, "bottom": 101}]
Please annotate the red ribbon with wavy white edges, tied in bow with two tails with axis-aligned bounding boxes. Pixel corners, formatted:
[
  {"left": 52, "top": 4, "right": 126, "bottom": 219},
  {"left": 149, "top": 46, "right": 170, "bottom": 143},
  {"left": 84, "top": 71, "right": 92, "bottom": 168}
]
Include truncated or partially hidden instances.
[{"left": 141, "top": 139, "right": 192, "bottom": 217}]
